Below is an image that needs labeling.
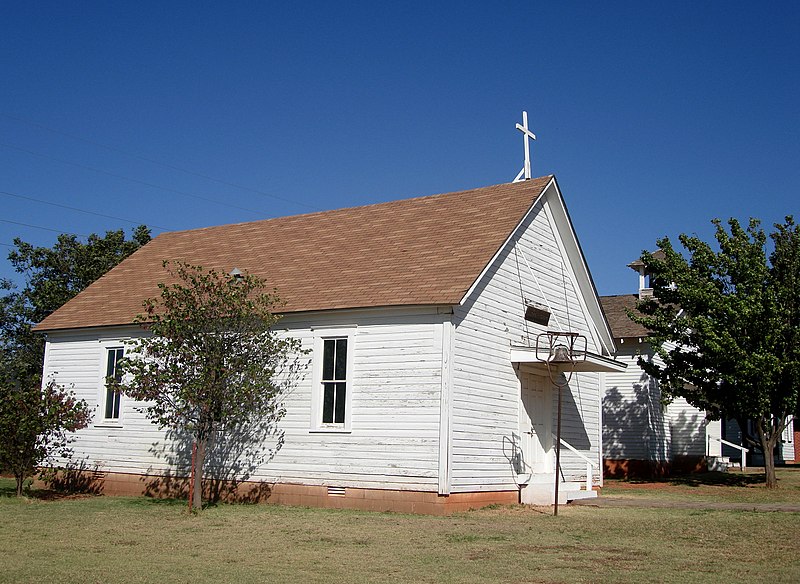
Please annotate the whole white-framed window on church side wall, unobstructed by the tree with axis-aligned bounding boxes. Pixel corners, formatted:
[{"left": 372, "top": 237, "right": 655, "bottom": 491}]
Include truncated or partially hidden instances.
[{"left": 311, "top": 328, "right": 354, "bottom": 432}]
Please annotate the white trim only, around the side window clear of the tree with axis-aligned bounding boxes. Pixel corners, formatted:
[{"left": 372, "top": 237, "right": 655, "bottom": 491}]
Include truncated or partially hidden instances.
[{"left": 309, "top": 326, "right": 356, "bottom": 434}]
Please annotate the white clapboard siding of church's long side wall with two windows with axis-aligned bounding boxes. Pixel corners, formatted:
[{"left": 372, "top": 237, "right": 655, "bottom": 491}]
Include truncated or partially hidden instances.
[{"left": 45, "top": 309, "right": 449, "bottom": 490}]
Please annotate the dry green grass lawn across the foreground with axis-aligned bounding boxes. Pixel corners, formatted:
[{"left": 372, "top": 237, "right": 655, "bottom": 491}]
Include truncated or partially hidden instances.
[{"left": 0, "top": 469, "right": 800, "bottom": 584}]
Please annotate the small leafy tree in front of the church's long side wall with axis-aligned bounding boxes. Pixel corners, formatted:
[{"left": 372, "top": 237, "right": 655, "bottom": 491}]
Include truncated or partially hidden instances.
[{"left": 109, "top": 262, "right": 299, "bottom": 509}]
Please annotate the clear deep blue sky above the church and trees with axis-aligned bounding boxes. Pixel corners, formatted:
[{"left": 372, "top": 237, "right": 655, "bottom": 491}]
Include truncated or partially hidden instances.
[{"left": 0, "top": 1, "right": 800, "bottom": 294}]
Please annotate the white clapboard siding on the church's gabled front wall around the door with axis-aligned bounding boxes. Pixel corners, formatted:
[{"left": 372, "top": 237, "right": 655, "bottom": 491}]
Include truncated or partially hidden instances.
[{"left": 451, "top": 194, "right": 600, "bottom": 492}]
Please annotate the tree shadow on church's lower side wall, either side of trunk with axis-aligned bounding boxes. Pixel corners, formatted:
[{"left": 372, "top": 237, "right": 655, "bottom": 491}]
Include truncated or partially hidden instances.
[{"left": 141, "top": 419, "right": 284, "bottom": 503}]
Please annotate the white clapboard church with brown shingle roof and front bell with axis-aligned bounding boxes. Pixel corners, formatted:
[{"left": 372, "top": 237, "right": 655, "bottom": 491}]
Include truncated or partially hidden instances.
[{"left": 36, "top": 176, "right": 623, "bottom": 513}]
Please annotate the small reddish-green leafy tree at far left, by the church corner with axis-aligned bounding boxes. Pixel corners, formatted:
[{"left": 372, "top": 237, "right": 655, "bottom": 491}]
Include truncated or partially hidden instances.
[{"left": 0, "top": 376, "right": 91, "bottom": 496}]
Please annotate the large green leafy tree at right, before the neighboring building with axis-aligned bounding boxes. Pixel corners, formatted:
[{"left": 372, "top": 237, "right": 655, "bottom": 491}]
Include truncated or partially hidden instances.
[{"left": 630, "top": 217, "right": 800, "bottom": 488}]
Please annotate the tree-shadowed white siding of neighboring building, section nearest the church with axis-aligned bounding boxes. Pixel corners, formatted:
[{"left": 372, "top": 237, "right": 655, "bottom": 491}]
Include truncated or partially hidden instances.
[{"left": 603, "top": 339, "right": 670, "bottom": 462}]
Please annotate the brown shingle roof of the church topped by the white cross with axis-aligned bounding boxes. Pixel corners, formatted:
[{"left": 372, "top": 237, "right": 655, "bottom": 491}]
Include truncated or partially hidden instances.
[{"left": 36, "top": 176, "right": 553, "bottom": 331}]
